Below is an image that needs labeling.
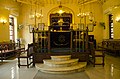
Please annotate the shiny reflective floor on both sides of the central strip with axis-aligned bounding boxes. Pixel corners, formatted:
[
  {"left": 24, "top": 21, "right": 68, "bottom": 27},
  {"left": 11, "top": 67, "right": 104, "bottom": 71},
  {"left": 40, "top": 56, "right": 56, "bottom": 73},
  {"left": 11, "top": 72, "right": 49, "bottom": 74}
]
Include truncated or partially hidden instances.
[{"left": 0, "top": 55, "right": 120, "bottom": 79}]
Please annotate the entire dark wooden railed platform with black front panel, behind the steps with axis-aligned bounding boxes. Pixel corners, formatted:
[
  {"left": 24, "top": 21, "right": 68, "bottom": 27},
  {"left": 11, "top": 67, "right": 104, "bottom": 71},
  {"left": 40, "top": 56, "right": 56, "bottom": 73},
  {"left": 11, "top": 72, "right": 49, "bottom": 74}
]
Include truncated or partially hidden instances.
[{"left": 33, "top": 27, "right": 89, "bottom": 64}]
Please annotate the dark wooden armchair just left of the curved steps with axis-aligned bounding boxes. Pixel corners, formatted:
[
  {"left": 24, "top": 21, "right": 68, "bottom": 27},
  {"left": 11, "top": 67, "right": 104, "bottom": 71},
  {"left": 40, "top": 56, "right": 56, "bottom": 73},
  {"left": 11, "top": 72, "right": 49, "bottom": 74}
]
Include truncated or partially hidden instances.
[{"left": 17, "top": 44, "right": 34, "bottom": 68}]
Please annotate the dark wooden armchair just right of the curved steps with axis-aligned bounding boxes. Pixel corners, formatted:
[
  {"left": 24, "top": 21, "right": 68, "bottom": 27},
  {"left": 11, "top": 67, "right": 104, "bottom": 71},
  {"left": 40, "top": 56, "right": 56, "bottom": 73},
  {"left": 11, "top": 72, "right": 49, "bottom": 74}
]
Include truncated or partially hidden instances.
[{"left": 89, "top": 43, "right": 105, "bottom": 67}]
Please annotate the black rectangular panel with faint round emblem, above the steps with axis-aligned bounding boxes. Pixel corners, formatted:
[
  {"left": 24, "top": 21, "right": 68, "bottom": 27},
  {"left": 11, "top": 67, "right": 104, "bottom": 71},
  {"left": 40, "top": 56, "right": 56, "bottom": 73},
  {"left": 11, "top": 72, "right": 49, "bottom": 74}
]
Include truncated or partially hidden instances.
[{"left": 50, "top": 31, "right": 72, "bottom": 48}]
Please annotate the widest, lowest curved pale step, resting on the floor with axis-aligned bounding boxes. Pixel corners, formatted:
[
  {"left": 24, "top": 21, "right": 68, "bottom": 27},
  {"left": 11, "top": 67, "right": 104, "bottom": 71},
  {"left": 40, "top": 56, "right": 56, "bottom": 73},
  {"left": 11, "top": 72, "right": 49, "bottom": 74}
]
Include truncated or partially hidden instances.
[{"left": 36, "top": 62, "right": 87, "bottom": 74}]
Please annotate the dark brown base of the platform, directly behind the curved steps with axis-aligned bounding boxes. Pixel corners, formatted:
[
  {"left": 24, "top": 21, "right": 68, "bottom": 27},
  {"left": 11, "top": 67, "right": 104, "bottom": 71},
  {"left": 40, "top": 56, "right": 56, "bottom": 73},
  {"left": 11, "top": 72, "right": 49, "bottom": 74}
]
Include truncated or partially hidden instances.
[{"left": 34, "top": 52, "right": 89, "bottom": 64}]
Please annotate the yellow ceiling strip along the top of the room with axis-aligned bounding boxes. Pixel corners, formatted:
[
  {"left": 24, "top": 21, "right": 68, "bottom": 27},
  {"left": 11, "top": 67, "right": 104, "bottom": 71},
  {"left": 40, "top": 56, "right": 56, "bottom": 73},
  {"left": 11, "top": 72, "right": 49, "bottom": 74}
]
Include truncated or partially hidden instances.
[{"left": 16, "top": 0, "right": 106, "bottom": 5}]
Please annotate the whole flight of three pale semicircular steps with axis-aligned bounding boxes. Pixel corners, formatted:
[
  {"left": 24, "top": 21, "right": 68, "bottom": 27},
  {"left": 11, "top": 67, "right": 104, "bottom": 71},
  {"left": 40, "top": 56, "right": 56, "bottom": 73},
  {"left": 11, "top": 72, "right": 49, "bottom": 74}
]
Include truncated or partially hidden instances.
[{"left": 36, "top": 55, "right": 87, "bottom": 74}]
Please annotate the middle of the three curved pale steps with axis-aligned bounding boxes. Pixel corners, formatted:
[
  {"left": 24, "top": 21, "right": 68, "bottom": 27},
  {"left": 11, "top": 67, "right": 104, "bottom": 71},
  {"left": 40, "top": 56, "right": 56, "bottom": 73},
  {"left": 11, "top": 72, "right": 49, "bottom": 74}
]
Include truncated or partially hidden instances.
[{"left": 43, "top": 59, "right": 79, "bottom": 67}]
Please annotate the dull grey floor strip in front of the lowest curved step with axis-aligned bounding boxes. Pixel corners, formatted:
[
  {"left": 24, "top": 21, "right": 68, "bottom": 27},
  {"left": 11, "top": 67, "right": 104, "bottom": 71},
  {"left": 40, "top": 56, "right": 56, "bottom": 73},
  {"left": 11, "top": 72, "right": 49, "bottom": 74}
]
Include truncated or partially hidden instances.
[{"left": 33, "top": 71, "right": 90, "bottom": 79}]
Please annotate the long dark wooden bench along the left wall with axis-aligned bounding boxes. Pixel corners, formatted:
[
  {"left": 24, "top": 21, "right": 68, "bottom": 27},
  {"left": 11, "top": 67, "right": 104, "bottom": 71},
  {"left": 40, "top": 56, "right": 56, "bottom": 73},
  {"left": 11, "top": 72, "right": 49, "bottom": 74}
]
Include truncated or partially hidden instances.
[{"left": 0, "top": 42, "right": 25, "bottom": 62}]
